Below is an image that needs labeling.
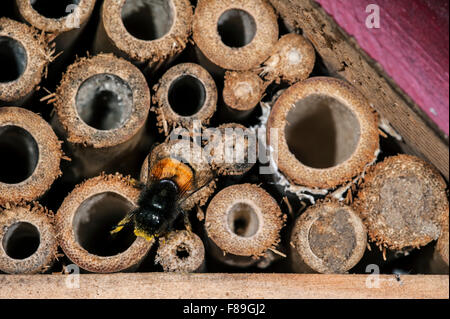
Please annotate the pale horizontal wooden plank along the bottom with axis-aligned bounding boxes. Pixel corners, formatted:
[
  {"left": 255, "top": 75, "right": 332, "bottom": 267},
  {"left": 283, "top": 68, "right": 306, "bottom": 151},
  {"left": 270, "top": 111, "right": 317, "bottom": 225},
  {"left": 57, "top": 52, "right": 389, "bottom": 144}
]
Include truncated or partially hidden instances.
[{"left": 0, "top": 273, "right": 449, "bottom": 299}]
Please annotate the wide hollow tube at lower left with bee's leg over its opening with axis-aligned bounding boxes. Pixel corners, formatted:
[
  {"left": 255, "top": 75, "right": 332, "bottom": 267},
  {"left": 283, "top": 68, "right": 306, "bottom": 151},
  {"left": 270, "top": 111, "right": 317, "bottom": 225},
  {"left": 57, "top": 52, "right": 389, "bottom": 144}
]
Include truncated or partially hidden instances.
[{"left": 56, "top": 174, "right": 154, "bottom": 273}]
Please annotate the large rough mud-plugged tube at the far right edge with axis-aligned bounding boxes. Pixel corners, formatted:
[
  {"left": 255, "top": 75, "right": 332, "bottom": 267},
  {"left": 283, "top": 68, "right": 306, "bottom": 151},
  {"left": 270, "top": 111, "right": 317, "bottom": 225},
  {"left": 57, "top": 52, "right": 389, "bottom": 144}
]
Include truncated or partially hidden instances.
[{"left": 354, "top": 155, "right": 449, "bottom": 250}]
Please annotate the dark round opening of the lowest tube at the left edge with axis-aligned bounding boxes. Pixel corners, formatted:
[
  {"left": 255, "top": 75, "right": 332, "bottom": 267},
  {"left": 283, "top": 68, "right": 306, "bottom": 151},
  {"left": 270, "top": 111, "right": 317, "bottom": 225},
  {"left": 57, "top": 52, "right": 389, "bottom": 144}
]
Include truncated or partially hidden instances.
[{"left": 2, "top": 222, "right": 41, "bottom": 259}]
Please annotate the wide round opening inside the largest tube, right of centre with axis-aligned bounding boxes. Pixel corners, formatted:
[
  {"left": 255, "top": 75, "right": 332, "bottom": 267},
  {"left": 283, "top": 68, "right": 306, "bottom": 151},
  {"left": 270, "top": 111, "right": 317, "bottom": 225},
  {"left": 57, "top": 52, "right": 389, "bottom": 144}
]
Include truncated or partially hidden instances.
[{"left": 286, "top": 94, "right": 360, "bottom": 169}]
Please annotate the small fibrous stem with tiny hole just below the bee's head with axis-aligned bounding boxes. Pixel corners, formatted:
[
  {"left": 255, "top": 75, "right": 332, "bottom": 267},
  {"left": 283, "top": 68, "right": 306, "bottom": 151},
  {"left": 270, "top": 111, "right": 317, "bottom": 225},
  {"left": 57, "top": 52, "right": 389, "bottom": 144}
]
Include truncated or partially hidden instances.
[{"left": 155, "top": 230, "right": 205, "bottom": 273}]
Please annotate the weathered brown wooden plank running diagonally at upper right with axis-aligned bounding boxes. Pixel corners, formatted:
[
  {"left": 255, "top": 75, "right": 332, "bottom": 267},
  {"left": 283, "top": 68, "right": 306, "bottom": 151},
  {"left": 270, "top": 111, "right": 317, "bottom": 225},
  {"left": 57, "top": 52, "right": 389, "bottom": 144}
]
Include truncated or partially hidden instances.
[{"left": 270, "top": 0, "right": 449, "bottom": 180}]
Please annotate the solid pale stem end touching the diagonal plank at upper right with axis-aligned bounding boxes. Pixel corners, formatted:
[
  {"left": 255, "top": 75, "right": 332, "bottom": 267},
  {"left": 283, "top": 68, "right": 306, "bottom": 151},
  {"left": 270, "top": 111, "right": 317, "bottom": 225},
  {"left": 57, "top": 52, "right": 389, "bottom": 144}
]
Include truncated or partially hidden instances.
[{"left": 262, "top": 33, "right": 316, "bottom": 84}]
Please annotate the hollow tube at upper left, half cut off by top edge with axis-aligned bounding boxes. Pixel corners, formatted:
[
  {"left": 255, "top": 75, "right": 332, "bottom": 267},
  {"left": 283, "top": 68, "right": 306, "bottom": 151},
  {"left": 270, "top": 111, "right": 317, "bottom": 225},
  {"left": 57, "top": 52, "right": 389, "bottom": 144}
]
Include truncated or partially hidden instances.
[{"left": 15, "top": 0, "right": 95, "bottom": 74}]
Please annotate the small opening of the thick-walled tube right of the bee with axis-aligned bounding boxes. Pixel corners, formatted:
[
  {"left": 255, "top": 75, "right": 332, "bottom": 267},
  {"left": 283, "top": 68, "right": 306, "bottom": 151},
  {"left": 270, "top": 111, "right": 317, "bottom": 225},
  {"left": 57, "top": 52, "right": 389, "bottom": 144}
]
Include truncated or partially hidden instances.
[{"left": 228, "top": 203, "right": 259, "bottom": 237}]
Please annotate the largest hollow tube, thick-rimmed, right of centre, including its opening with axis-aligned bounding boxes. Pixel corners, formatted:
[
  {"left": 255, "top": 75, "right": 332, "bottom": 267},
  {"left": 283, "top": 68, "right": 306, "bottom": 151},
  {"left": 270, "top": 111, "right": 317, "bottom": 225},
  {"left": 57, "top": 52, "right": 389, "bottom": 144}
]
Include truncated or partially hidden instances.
[{"left": 267, "top": 77, "right": 379, "bottom": 189}]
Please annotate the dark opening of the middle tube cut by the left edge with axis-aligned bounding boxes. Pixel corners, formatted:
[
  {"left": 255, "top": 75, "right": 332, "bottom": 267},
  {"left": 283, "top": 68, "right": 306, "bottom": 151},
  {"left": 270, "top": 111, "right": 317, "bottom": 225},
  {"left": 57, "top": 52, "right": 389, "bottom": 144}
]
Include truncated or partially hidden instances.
[{"left": 0, "top": 125, "right": 39, "bottom": 184}]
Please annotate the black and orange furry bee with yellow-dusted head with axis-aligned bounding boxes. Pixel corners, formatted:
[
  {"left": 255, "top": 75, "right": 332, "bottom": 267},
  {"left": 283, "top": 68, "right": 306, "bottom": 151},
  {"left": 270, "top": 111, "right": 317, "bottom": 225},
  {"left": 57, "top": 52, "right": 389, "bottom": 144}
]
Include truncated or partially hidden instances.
[{"left": 111, "top": 158, "right": 213, "bottom": 240}]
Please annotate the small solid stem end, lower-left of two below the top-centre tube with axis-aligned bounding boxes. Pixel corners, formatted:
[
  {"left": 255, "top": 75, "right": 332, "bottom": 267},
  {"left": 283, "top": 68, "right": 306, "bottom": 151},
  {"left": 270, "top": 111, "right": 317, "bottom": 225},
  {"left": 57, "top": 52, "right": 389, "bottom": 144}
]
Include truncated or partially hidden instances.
[{"left": 223, "top": 71, "right": 266, "bottom": 111}]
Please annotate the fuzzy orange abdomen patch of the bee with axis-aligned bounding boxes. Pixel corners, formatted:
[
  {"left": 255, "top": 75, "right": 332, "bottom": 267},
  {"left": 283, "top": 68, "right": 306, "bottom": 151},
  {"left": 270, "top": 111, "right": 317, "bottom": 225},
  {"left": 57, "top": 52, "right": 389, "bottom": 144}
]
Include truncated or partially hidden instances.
[{"left": 150, "top": 158, "right": 194, "bottom": 193}]
